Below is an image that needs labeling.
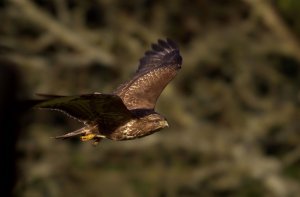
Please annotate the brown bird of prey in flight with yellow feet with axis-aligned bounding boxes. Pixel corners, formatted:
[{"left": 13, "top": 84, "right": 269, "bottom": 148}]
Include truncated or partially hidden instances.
[{"left": 35, "top": 39, "right": 182, "bottom": 144}]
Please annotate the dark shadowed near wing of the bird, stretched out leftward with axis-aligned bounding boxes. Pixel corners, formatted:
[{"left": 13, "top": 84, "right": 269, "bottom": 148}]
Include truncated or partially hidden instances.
[{"left": 35, "top": 94, "right": 132, "bottom": 129}]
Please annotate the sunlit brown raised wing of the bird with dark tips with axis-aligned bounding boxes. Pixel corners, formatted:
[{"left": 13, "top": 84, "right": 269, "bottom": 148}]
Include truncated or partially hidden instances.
[{"left": 114, "top": 39, "right": 182, "bottom": 110}]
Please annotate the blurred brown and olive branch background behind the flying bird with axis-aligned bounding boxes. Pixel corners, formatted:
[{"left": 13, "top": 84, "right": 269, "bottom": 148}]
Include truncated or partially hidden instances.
[{"left": 0, "top": 0, "right": 300, "bottom": 197}]
